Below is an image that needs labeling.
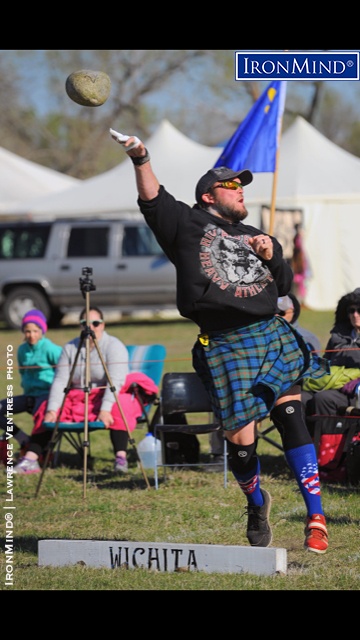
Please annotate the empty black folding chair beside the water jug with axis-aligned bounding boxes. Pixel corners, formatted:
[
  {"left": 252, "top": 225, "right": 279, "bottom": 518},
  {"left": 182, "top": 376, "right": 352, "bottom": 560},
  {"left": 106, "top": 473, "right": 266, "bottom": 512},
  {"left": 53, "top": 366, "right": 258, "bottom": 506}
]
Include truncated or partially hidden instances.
[{"left": 152, "top": 372, "right": 227, "bottom": 489}]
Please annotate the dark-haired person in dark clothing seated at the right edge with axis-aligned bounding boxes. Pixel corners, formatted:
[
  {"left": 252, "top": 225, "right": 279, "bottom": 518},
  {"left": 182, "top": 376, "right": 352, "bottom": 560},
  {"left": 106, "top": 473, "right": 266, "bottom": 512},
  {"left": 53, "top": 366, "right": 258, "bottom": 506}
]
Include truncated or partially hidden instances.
[{"left": 301, "top": 287, "right": 360, "bottom": 433}]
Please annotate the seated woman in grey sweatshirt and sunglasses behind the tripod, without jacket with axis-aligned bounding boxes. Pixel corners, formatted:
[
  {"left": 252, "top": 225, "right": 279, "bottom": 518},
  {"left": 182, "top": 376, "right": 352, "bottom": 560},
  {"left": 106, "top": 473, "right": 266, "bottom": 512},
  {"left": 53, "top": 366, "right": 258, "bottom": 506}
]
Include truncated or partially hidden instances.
[{"left": 14, "top": 307, "right": 129, "bottom": 473}]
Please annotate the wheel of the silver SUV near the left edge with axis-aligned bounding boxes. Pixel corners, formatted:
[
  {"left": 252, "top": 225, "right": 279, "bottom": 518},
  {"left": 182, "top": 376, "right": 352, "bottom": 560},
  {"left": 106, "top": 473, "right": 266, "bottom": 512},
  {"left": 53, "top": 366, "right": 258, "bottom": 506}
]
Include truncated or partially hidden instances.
[{"left": 3, "top": 287, "right": 50, "bottom": 329}]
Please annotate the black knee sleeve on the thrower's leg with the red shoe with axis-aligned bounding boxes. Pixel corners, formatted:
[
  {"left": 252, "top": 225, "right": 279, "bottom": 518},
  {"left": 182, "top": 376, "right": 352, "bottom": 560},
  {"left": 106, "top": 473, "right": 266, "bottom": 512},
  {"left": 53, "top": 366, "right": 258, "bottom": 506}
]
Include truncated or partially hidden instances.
[{"left": 270, "top": 400, "right": 312, "bottom": 451}]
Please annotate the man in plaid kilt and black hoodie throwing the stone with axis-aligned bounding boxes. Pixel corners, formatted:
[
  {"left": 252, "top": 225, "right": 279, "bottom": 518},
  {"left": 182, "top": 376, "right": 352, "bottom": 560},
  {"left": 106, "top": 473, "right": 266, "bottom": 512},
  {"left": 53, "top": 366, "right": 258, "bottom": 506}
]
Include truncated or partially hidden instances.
[{"left": 110, "top": 130, "right": 328, "bottom": 553}]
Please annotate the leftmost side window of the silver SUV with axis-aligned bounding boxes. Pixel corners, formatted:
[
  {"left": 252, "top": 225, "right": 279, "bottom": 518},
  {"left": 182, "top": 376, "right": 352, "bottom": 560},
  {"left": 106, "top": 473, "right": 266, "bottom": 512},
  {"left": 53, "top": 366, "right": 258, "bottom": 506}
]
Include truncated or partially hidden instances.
[{"left": 0, "top": 225, "right": 50, "bottom": 260}]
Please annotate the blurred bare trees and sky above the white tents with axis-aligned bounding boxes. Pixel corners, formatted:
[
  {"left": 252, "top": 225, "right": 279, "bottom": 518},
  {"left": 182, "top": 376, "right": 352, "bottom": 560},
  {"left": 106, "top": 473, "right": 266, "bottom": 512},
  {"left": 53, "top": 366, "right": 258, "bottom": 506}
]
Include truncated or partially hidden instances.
[{"left": 0, "top": 49, "right": 360, "bottom": 178}]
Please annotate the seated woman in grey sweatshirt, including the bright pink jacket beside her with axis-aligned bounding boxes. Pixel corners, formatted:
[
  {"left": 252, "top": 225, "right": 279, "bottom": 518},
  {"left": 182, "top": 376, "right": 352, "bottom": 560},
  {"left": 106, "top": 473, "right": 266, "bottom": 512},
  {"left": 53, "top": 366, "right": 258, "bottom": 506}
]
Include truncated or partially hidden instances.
[{"left": 14, "top": 307, "right": 158, "bottom": 474}]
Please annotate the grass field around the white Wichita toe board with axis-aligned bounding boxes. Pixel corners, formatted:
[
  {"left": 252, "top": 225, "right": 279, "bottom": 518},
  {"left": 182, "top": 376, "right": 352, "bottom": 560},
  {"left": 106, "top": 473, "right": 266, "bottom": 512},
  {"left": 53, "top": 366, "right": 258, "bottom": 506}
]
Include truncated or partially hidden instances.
[{"left": 0, "top": 309, "right": 360, "bottom": 591}]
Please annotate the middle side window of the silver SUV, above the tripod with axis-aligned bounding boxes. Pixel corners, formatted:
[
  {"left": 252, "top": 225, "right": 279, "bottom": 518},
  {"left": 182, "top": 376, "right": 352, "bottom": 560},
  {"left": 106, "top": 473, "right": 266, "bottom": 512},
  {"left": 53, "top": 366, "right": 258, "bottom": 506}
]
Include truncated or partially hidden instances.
[{"left": 67, "top": 226, "right": 109, "bottom": 258}]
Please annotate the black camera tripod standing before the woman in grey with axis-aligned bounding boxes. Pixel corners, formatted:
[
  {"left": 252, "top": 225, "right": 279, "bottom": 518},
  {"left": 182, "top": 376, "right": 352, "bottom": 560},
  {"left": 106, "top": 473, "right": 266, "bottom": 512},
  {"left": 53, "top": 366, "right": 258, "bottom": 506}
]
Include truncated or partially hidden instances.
[{"left": 35, "top": 267, "right": 150, "bottom": 499}]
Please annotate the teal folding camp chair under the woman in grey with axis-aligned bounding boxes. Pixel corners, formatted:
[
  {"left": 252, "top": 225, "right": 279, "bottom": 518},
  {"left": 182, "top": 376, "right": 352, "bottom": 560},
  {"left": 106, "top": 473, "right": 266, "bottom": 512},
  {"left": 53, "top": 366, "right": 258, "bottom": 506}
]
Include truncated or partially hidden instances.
[{"left": 43, "top": 344, "right": 166, "bottom": 466}]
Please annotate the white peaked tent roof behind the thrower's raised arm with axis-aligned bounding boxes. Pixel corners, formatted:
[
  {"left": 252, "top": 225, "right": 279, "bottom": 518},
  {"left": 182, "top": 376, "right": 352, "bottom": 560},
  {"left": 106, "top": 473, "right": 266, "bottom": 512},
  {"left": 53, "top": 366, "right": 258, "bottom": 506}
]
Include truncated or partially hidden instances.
[{"left": 4, "top": 120, "right": 222, "bottom": 219}]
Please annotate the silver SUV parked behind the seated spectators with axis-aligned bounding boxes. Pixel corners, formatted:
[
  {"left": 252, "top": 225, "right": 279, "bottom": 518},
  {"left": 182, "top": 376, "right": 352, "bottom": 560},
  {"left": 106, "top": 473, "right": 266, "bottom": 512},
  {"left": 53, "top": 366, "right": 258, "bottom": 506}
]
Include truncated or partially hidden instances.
[{"left": 0, "top": 214, "right": 176, "bottom": 329}]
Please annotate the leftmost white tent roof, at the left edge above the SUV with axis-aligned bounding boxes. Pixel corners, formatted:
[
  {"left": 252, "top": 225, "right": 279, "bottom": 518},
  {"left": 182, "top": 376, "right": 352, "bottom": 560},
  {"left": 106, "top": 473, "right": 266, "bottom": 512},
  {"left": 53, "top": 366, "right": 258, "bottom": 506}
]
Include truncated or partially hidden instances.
[{"left": 0, "top": 147, "right": 81, "bottom": 211}]
